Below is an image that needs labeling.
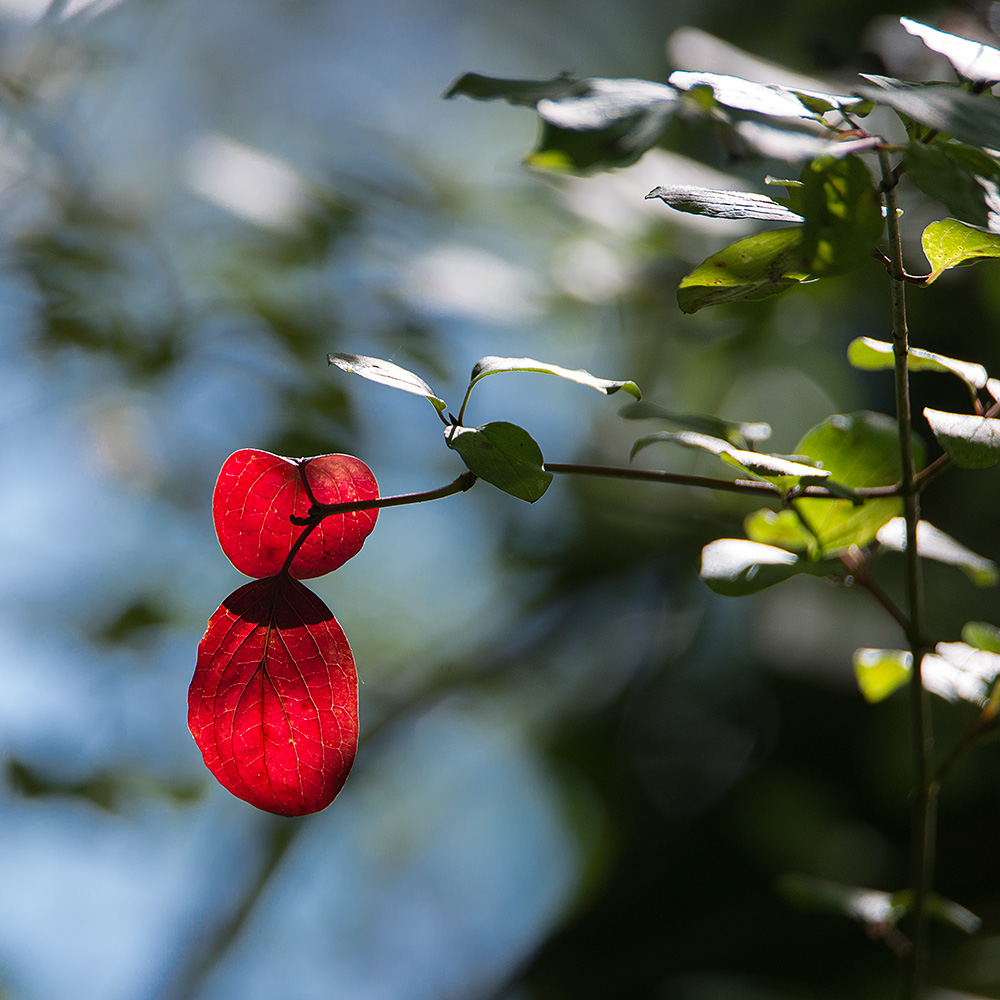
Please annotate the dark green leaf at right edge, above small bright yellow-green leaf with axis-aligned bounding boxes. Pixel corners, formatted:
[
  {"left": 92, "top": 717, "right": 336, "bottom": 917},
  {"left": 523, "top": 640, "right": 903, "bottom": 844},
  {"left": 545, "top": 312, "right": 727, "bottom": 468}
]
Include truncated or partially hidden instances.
[{"left": 903, "top": 139, "right": 1000, "bottom": 229}]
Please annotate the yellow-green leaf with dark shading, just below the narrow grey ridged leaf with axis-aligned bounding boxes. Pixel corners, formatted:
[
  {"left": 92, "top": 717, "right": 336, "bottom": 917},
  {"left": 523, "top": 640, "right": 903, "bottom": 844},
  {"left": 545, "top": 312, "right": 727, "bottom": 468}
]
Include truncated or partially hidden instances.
[{"left": 677, "top": 226, "right": 810, "bottom": 313}]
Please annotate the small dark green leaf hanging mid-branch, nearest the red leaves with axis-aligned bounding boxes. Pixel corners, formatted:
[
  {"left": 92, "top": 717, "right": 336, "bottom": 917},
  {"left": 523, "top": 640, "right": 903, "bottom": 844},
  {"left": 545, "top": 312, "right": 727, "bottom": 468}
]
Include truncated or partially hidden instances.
[{"left": 444, "top": 421, "right": 552, "bottom": 503}]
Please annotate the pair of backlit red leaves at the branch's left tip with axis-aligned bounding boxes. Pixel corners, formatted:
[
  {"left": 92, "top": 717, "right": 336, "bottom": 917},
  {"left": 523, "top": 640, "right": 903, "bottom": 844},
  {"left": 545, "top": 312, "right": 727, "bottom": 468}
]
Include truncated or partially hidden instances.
[{"left": 188, "top": 449, "right": 378, "bottom": 816}]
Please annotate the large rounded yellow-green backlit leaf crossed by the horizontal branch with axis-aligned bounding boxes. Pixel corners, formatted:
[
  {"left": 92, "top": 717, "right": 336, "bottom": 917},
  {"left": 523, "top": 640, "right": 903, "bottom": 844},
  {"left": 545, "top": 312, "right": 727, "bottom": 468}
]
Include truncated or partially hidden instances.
[{"left": 795, "top": 412, "right": 922, "bottom": 555}]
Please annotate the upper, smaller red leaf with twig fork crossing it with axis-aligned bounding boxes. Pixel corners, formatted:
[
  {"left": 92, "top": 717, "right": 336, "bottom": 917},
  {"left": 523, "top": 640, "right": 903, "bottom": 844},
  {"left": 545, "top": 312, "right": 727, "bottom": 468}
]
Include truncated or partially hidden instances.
[{"left": 212, "top": 448, "right": 378, "bottom": 580}]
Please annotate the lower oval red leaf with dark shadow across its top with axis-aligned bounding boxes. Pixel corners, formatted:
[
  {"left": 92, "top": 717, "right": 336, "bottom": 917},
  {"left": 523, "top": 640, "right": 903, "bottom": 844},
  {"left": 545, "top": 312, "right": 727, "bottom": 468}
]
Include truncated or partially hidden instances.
[{"left": 188, "top": 574, "right": 358, "bottom": 816}]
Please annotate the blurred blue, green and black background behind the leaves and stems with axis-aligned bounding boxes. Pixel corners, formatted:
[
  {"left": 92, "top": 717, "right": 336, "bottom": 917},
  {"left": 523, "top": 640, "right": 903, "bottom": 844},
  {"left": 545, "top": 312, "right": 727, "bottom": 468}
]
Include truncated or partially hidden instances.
[{"left": 0, "top": 0, "right": 1000, "bottom": 1000}]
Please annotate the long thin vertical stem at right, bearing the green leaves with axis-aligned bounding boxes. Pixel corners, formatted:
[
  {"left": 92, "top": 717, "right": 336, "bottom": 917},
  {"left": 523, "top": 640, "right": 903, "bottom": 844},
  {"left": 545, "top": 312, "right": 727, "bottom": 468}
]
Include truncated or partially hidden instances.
[{"left": 879, "top": 150, "right": 937, "bottom": 1000}]
